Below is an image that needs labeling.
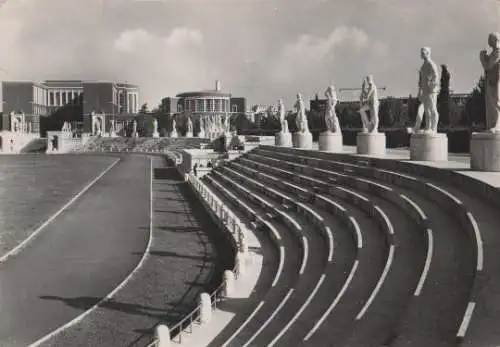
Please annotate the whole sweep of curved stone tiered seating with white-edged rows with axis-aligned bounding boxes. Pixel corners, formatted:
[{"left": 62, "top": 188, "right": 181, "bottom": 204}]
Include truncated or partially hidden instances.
[{"left": 198, "top": 146, "right": 500, "bottom": 346}]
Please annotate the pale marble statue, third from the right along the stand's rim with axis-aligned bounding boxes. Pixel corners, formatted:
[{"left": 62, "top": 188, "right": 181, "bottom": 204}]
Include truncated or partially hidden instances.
[{"left": 359, "top": 75, "right": 379, "bottom": 133}]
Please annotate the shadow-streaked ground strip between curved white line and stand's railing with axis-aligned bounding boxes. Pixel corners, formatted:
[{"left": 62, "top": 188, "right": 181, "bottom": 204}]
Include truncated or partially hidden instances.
[{"left": 43, "top": 156, "right": 233, "bottom": 346}]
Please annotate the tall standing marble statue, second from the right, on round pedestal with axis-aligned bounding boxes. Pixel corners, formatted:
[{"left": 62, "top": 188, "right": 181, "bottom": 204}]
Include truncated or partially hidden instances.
[{"left": 413, "top": 47, "right": 439, "bottom": 133}]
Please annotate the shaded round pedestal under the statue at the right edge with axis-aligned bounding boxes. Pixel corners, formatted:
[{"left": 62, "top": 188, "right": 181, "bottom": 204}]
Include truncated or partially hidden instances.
[{"left": 470, "top": 133, "right": 500, "bottom": 172}]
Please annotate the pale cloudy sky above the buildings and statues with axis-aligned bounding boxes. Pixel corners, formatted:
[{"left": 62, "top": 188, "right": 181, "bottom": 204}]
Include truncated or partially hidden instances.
[{"left": 0, "top": 0, "right": 500, "bottom": 107}]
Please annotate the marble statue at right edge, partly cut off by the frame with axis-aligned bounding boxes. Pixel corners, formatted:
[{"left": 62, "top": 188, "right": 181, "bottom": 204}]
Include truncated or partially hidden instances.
[{"left": 479, "top": 32, "right": 500, "bottom": 133}]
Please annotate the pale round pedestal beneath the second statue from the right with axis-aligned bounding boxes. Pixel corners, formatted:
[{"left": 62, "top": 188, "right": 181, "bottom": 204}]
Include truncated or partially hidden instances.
[{"left": 410, "top": 133, "right": 448, "bottom": 161}]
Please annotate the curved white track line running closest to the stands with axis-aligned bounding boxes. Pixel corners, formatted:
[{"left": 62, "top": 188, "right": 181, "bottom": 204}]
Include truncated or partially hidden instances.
[{"left": 28, "top": 157, "right": 153, "bottom": 347}]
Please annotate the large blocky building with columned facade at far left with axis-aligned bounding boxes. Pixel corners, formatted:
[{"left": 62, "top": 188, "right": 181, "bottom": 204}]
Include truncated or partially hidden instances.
[{"left": 2, "top": 80, "right": 140, "bottom": 132}]
